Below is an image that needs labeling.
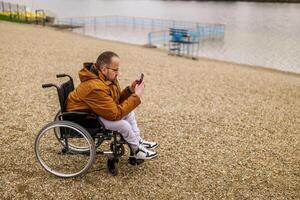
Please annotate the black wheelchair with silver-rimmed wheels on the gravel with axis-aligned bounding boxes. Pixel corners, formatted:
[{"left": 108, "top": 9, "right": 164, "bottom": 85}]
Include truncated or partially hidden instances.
[{"left": 34, "top": 74, "right": 143, "bottom": 178}]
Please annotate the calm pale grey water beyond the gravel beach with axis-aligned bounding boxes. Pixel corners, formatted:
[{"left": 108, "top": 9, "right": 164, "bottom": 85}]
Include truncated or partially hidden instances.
[{"left": 11, "top": 0, "right": 300, "bottom": 73}]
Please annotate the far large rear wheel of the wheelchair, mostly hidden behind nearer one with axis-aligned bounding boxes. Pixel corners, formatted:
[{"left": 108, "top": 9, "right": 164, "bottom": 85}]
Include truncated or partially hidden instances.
[{"left": 54, "top": 110, "right": 101, "bottom": 153}]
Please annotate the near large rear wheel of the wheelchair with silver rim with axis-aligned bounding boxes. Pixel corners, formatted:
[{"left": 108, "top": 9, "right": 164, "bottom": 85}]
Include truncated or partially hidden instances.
[{"left": 35, "top": 120, "right": 96, "bottom": 178}]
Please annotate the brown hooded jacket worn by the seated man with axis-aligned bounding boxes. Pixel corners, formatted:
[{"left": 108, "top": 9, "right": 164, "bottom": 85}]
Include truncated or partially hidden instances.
[{"left": 66, "top": 63, "right": 141, "bottom": 121}]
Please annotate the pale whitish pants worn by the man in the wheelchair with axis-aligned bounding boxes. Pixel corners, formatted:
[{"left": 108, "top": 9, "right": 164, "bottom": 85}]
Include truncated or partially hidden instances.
[{"left": 99, "top": 111, "right": 141, "bottom": 151}]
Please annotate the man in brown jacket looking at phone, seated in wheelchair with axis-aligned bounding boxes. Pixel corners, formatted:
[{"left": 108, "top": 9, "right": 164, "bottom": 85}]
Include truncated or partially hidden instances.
[{"left": 66, "top": 51, "right": 158, "bottom": 160}]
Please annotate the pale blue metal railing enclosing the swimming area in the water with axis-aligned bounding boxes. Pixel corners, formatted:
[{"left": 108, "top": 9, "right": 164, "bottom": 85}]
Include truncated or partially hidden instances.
[{"left": 55, "top": 16, "right": 225, "bottom": 43}]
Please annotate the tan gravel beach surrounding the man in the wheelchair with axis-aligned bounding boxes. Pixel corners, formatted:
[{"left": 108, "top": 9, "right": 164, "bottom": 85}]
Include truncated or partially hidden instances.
[{"left": 0, "top": 21, "right": 300, "bottom": 199}]
